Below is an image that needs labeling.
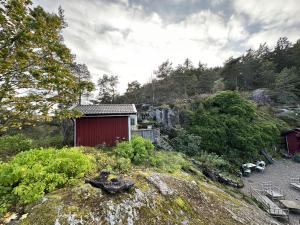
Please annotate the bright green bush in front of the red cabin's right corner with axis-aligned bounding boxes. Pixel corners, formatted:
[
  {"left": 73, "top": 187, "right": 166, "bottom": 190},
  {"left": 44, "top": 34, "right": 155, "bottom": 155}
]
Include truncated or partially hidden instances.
[{"left": 115, "top": 136, "right": 154, "bottom": 164}]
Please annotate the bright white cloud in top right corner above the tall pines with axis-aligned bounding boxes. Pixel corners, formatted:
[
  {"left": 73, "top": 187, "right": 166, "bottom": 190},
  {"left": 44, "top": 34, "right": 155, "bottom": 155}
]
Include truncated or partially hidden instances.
[{"left": 233, "top": 0, "right": 300, "bottom": 48}]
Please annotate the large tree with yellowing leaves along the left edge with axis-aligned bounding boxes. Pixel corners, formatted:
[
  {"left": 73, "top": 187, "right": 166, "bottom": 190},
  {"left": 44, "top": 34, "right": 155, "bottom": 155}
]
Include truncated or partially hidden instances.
[{"left": 0, "top": 0, "right": 91, "bottom": 134}]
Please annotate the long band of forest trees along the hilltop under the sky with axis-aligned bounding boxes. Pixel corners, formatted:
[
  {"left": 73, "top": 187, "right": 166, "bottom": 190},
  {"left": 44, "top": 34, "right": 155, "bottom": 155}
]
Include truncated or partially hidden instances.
[{"left": 116, "top": 37, "right": 300, "bottom": 105}]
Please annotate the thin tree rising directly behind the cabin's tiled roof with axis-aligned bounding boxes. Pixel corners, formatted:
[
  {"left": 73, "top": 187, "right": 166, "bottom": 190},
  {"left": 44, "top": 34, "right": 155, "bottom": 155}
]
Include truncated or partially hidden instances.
[{"left": 97, "top": 74, "right": 118, "bottom": 103}]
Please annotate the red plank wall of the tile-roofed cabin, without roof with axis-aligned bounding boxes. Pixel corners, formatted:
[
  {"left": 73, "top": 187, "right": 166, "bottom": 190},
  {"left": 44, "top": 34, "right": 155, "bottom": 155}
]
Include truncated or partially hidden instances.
[{"left": 76, "top": 116, "right": 128, "bottom": 147}]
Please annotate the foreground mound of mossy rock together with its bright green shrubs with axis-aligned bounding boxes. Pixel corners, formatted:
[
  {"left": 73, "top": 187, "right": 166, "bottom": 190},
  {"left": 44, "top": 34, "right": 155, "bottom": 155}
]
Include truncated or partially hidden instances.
[{"left": 0, "top": 144, "right": 275, "bottom": 225}]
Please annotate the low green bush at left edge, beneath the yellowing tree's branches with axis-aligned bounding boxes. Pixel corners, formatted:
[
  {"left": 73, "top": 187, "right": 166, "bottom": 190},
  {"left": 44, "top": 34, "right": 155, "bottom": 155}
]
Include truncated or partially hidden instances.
[{"left": 0, "top": 134, "right": 34, "bottom": 156}]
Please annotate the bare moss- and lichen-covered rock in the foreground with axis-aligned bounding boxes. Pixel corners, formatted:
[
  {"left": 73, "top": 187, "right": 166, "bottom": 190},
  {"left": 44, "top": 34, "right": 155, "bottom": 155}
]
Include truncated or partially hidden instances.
[{"left": 10, "top": 170, "right": 277, "bottom": 225}]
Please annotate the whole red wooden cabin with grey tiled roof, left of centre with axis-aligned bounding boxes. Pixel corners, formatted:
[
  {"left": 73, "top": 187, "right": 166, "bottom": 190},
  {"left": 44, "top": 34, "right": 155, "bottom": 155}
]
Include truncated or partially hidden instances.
[{"left": 74, "top": 104, "right": 137, "bottom": 147}]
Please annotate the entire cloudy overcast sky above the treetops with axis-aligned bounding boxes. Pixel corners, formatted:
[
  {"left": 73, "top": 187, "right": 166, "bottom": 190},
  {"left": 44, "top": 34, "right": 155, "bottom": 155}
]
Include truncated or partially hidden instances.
[{"left": 34, "top": 0, "right": 300, "bottom": 92}]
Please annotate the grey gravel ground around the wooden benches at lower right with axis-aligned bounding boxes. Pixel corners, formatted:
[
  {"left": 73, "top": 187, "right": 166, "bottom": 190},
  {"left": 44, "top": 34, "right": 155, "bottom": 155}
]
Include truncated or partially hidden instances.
[{"left": 242, "top": 160, "right": 300, "bottom": 225}]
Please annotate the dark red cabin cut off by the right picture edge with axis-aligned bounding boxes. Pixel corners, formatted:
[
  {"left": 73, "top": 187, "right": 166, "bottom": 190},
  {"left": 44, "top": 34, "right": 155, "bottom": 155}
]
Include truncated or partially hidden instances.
[{"left": 284, "top": 128, "right": 300, "bottom": 155}]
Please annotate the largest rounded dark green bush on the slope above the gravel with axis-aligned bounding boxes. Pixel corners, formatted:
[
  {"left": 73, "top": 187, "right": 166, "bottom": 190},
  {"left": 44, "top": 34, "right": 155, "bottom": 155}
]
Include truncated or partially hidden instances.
[{"left": 188, "top": 91, "right": 280, "bottom": 163}]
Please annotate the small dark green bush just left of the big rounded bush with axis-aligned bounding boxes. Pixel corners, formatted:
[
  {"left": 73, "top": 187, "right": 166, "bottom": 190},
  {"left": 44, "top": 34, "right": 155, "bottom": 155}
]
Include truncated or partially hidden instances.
[{"left": 171, "top": 129, "right": 201, "bottom": 155}]
